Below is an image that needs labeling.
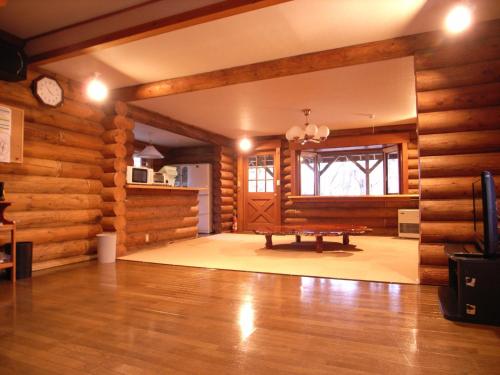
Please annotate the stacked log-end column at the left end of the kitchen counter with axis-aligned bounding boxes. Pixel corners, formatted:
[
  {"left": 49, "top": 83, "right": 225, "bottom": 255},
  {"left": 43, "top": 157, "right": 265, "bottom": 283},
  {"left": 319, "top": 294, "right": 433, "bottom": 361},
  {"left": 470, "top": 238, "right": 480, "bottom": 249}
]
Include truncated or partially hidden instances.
[{"left": 101, "top": 102, "right": 134, "bottom": 256}]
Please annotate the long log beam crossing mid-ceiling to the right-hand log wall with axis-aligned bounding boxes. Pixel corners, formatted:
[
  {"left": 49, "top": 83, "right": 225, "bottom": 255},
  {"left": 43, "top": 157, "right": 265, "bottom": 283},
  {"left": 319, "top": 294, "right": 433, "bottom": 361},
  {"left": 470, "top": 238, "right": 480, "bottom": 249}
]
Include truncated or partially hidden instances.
[{"left": 112, "top": 20, "right": 500, "bottom": 101}]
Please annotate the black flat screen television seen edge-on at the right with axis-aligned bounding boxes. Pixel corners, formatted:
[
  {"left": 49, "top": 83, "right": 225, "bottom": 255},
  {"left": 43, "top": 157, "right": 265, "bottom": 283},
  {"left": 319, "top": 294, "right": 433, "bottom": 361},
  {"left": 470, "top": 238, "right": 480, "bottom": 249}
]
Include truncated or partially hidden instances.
[{"left": 472, "top": 171, "right": 499, "bottom": 257}]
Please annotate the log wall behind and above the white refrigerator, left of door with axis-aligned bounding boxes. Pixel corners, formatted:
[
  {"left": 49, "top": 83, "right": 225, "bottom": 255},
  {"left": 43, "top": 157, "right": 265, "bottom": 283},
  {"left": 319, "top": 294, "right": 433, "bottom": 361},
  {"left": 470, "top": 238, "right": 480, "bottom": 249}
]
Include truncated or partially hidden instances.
[{"left": 163, "top": 146, "right": 237, "bottom": 233}]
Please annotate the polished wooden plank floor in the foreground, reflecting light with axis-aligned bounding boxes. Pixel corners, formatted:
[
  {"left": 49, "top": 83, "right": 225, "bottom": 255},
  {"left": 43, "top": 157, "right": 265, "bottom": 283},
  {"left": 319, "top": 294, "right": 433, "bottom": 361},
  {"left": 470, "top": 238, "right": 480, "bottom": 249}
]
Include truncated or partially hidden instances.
[{"left": 0, "top": 262, "right": 500, "bottom": 375}]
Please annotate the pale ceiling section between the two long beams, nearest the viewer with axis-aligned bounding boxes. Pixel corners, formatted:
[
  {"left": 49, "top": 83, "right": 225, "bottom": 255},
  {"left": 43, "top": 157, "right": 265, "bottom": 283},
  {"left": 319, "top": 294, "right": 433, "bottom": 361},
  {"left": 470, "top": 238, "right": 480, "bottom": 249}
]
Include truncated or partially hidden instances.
[{"left": 44, "top": 0, "right": 500, "bottom": 88}]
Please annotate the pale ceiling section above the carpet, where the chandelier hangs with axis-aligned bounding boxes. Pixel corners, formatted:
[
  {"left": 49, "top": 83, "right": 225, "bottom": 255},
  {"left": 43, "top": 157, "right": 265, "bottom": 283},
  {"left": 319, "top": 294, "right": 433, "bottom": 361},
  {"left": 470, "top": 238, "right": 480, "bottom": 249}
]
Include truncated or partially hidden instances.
[{"left": 134, "top": 57, "right": 416, "bottom": 138}]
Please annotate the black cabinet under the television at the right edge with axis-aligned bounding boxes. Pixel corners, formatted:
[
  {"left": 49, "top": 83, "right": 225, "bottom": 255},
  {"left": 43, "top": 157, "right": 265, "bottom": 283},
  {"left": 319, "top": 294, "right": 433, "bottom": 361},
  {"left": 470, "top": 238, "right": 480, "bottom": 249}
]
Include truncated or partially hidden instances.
[{"left": 439, "top": 244, "right": 500, "bottom": 325}]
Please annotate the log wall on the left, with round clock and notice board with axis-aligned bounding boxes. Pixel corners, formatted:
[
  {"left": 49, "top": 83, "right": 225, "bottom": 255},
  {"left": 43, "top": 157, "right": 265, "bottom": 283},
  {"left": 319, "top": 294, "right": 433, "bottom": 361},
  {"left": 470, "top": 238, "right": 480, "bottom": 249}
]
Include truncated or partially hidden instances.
[{"left": 0, "top": 71, "right": 105, "bottom": 269}]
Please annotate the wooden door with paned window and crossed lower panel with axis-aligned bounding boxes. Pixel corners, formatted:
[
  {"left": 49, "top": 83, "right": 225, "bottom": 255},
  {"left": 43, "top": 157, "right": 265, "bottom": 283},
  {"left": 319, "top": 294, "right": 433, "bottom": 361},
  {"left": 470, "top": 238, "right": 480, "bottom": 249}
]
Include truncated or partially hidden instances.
[{"left": 240, "top": 149, "right": 281, "bottom": 231}]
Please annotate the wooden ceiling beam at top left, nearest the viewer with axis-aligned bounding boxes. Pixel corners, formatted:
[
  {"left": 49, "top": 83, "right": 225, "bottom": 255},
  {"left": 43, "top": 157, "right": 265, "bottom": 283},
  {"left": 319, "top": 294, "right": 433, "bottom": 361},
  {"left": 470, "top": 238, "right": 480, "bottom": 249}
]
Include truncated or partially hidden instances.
[{"left": 29, "top": 0, "right": 290, "bottom": 65}]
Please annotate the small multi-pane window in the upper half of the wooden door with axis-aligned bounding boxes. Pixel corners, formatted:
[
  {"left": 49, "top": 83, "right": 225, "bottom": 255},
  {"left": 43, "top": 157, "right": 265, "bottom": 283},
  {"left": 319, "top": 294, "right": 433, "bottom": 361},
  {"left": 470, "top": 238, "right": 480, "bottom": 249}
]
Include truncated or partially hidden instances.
[{"left": 248, "top": 155, "right": 274, "bottom": 193}]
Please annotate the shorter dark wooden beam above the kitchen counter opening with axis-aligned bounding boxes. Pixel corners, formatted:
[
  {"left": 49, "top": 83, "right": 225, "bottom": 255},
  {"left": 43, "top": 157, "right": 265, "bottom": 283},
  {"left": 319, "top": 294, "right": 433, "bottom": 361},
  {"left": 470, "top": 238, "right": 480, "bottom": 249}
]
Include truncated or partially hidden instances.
[{"left": 127, "top": 104, "right": 234, "bottom": 146}]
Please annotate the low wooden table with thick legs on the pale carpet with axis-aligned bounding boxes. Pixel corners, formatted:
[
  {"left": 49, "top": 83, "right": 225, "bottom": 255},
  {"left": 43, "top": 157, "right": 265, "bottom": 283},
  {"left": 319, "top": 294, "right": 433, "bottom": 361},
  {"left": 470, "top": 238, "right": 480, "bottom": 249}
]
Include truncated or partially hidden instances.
[{"left": 254, "top": 224, "right": 371, "bottom": 253}]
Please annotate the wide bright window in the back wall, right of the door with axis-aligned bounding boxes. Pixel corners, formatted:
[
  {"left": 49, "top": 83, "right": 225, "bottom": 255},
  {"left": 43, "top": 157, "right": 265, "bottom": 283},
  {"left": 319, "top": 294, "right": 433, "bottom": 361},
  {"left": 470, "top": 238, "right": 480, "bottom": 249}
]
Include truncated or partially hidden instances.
[{"left": 300, "top": 145, "right": 400, "bottom": 196}]
